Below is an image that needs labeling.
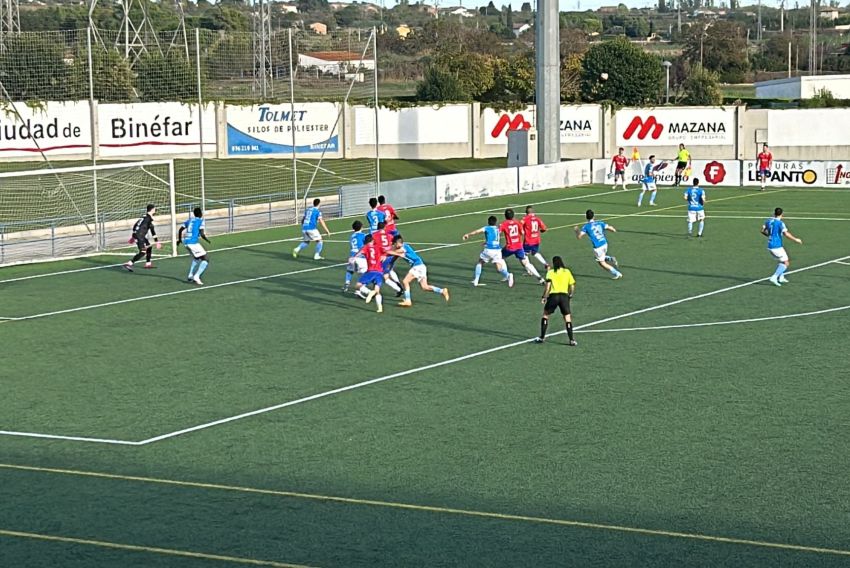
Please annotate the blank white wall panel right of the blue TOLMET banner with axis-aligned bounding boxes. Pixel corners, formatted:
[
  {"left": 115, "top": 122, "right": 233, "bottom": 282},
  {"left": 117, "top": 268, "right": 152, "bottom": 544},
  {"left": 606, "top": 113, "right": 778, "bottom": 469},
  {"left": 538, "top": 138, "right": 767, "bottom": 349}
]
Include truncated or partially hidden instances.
[{"left": 354, "top": 105, "right": 471, "bottom": 146}]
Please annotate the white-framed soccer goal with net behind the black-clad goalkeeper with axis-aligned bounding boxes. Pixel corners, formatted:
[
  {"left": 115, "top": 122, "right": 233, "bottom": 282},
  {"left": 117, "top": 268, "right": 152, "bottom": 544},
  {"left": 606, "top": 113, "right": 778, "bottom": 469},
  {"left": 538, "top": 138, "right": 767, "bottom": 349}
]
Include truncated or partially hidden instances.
[{"left": 0, "top": 160, "right": 177, "bottom": 266}]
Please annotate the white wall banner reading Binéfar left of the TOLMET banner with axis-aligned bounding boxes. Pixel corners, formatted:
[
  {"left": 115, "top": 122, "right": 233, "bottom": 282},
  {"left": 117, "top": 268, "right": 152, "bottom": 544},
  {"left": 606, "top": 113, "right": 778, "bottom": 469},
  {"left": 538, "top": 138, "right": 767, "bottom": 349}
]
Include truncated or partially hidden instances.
[{"left": 97, "top": 103, "right": 216, "bottom": 157}]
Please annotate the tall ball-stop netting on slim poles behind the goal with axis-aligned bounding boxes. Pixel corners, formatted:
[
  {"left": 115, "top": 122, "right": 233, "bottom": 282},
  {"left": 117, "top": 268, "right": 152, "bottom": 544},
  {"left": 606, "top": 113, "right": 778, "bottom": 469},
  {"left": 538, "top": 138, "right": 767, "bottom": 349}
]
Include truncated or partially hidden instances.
[{"left": 0, "top": 28, "right": 379, "bottom": 262}]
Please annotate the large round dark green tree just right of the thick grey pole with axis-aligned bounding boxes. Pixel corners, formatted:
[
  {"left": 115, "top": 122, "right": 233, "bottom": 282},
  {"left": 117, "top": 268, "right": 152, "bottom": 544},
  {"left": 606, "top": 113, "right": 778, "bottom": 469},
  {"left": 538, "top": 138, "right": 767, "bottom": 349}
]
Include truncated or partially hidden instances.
[{"left": 581, "top": 37, "right": 664, "bottom": 105}]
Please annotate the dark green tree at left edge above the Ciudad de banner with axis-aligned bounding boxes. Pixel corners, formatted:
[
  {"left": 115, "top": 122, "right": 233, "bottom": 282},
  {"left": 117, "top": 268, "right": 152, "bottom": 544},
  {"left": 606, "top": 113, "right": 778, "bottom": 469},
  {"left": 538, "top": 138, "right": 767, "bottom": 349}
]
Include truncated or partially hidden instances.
[{"left": 0, "top": 34, "right": 74, "bottom": 101}]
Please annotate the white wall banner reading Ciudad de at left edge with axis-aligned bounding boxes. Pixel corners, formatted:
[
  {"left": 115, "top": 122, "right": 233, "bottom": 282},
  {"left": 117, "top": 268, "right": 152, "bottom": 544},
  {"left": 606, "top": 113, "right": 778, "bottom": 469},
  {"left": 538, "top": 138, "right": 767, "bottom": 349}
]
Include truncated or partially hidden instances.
[{"left": 0, "top": 101, "right": 92, "bottom": 159}]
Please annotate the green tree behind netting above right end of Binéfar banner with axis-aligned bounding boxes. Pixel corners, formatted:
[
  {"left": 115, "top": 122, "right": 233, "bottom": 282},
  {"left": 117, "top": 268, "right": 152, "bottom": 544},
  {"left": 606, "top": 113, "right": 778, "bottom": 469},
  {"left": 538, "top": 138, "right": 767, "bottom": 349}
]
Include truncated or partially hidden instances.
[{"left": 136, "top": 50, "right": 198, "bottom": 101}]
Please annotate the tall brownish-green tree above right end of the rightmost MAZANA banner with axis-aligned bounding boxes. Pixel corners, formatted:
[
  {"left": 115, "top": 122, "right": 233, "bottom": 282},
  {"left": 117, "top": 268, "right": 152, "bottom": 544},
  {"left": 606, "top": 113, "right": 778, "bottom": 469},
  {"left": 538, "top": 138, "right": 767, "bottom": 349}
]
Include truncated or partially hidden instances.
[{"left": 683, "top": 20, "right": 749, "bottom": 83}]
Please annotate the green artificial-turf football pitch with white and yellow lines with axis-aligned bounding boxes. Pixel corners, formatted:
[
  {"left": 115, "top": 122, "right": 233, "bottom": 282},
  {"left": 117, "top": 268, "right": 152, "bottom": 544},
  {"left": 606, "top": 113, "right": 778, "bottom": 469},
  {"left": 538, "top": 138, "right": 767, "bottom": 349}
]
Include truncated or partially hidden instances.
[{"left": 0, "top": 185, "right": 850, "bottom": 568}]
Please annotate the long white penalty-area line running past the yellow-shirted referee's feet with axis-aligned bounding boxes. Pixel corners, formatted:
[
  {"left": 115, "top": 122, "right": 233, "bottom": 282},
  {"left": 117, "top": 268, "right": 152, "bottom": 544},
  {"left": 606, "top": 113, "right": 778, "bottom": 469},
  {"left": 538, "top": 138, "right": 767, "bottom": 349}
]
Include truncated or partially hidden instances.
[{"left": 127, "top": 256, "right": 850, "bottom": 445}]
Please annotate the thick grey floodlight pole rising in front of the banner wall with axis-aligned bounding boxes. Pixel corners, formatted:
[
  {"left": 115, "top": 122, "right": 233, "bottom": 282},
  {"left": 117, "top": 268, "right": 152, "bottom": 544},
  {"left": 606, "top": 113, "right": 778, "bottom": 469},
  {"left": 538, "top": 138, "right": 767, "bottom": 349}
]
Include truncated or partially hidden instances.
[{"left": 535, "top": 0, "right": 561, "bottom": 164}]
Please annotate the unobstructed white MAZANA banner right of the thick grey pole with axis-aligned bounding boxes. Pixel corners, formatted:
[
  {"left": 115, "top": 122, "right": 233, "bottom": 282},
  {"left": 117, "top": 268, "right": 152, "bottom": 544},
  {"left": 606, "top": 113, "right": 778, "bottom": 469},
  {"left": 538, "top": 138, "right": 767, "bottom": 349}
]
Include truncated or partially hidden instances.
[{"left": 614, "top": 107, "right": 735, "bottom": 148}]
